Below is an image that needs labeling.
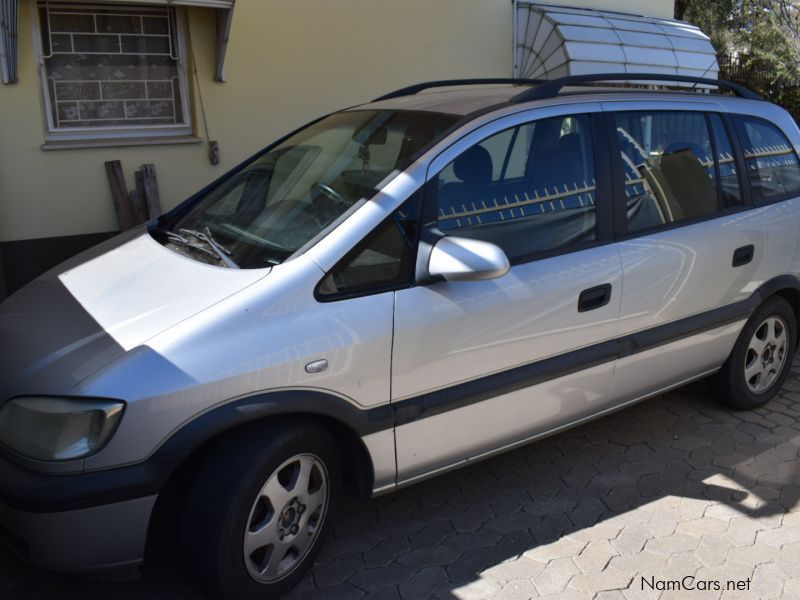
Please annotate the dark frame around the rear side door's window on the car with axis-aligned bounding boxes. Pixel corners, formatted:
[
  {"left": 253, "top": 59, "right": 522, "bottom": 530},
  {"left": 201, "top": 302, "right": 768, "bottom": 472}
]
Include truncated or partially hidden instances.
[{"left": 604, "top": 102, "right": 752, "bottom": 241}]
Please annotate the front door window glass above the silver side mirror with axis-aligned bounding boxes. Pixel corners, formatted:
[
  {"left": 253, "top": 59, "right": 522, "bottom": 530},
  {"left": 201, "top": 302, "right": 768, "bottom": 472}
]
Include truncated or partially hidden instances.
[{"left": 426, "top": 115, "right": 596, "bottom": 262}]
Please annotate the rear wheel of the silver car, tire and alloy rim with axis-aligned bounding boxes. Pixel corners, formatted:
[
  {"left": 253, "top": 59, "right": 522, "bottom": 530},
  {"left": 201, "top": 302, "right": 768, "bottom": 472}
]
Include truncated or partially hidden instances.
[{"left": 716, "top": 296, "right": 797, "bottom": 410}]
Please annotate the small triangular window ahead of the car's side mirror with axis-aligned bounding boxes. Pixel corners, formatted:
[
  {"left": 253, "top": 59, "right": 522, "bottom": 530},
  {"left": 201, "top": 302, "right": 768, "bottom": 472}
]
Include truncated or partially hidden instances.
[{"left": 317, "top": 192, "right": 420, "bottom": 299}]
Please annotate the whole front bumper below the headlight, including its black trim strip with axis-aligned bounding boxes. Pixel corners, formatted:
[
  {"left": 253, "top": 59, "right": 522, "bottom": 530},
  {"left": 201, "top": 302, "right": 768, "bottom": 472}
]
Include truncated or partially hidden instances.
[{"left": 0, "top": 452, "right": 182, "bottom": 572}]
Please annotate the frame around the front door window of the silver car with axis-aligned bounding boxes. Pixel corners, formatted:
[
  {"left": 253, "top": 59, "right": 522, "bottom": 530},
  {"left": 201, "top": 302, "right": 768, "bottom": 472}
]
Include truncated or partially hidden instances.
[{"left": 416, "top": 102, "right": 615, "bottom": 268}]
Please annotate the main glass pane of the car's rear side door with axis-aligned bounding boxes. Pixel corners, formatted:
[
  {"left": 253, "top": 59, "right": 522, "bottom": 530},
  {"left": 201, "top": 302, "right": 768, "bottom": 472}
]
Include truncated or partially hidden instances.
[{"left": 614, "top": 112, "right": 717, "bottom": 232}]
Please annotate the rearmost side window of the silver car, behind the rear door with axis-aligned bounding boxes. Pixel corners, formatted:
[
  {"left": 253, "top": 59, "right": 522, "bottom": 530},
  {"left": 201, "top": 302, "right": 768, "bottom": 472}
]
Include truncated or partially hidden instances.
[{"left": 735, "top": 116, "right": 800, "bottom": 201}]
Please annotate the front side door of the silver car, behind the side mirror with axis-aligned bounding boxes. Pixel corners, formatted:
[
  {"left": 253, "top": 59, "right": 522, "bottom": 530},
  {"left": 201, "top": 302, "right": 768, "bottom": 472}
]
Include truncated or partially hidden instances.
[{"left": 392, "top": 104, "right": 621, "bottom": 482}]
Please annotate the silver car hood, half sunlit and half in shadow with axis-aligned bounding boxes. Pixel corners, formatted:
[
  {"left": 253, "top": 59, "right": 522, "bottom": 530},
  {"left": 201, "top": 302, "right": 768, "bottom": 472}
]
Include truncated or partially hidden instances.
[{"left": 0, "top": 229, "right": 269, "bottom": 404}]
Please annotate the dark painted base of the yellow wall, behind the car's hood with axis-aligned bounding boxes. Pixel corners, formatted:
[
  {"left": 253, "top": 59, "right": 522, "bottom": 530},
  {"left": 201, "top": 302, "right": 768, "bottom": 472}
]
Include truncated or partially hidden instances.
[{"left": 0, "top": 231, "right": 117, "bottom": 299}]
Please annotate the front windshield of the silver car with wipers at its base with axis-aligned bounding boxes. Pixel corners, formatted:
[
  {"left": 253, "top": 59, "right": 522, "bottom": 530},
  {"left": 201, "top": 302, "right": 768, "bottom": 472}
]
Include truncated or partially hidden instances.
[{"left": 154, "top": 110, "right": 458, "bottom": 268}]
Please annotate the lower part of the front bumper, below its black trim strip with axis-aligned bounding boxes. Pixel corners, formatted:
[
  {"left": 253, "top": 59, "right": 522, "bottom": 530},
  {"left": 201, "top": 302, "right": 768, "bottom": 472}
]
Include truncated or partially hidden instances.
[{"left": 0, "top": 495, "right": 157, "bottom": 572}]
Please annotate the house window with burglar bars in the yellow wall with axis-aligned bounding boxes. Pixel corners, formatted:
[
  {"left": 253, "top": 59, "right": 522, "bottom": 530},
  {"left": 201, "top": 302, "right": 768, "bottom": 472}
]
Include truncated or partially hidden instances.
[{"left": 39, "top": 2, "right": 190, "bottom": 138}]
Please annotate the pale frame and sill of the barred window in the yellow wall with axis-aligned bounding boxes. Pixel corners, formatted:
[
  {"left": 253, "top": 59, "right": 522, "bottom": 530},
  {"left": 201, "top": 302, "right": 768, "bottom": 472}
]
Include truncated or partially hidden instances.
[{"left": 30, "top": 0, "right": 194, "bottom": 147}]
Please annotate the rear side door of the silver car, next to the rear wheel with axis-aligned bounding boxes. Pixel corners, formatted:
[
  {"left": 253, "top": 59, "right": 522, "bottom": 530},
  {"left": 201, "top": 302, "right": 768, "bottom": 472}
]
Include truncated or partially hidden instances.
[{"left": 605, "top": 102, "right": 796, "bottom": 403}]
